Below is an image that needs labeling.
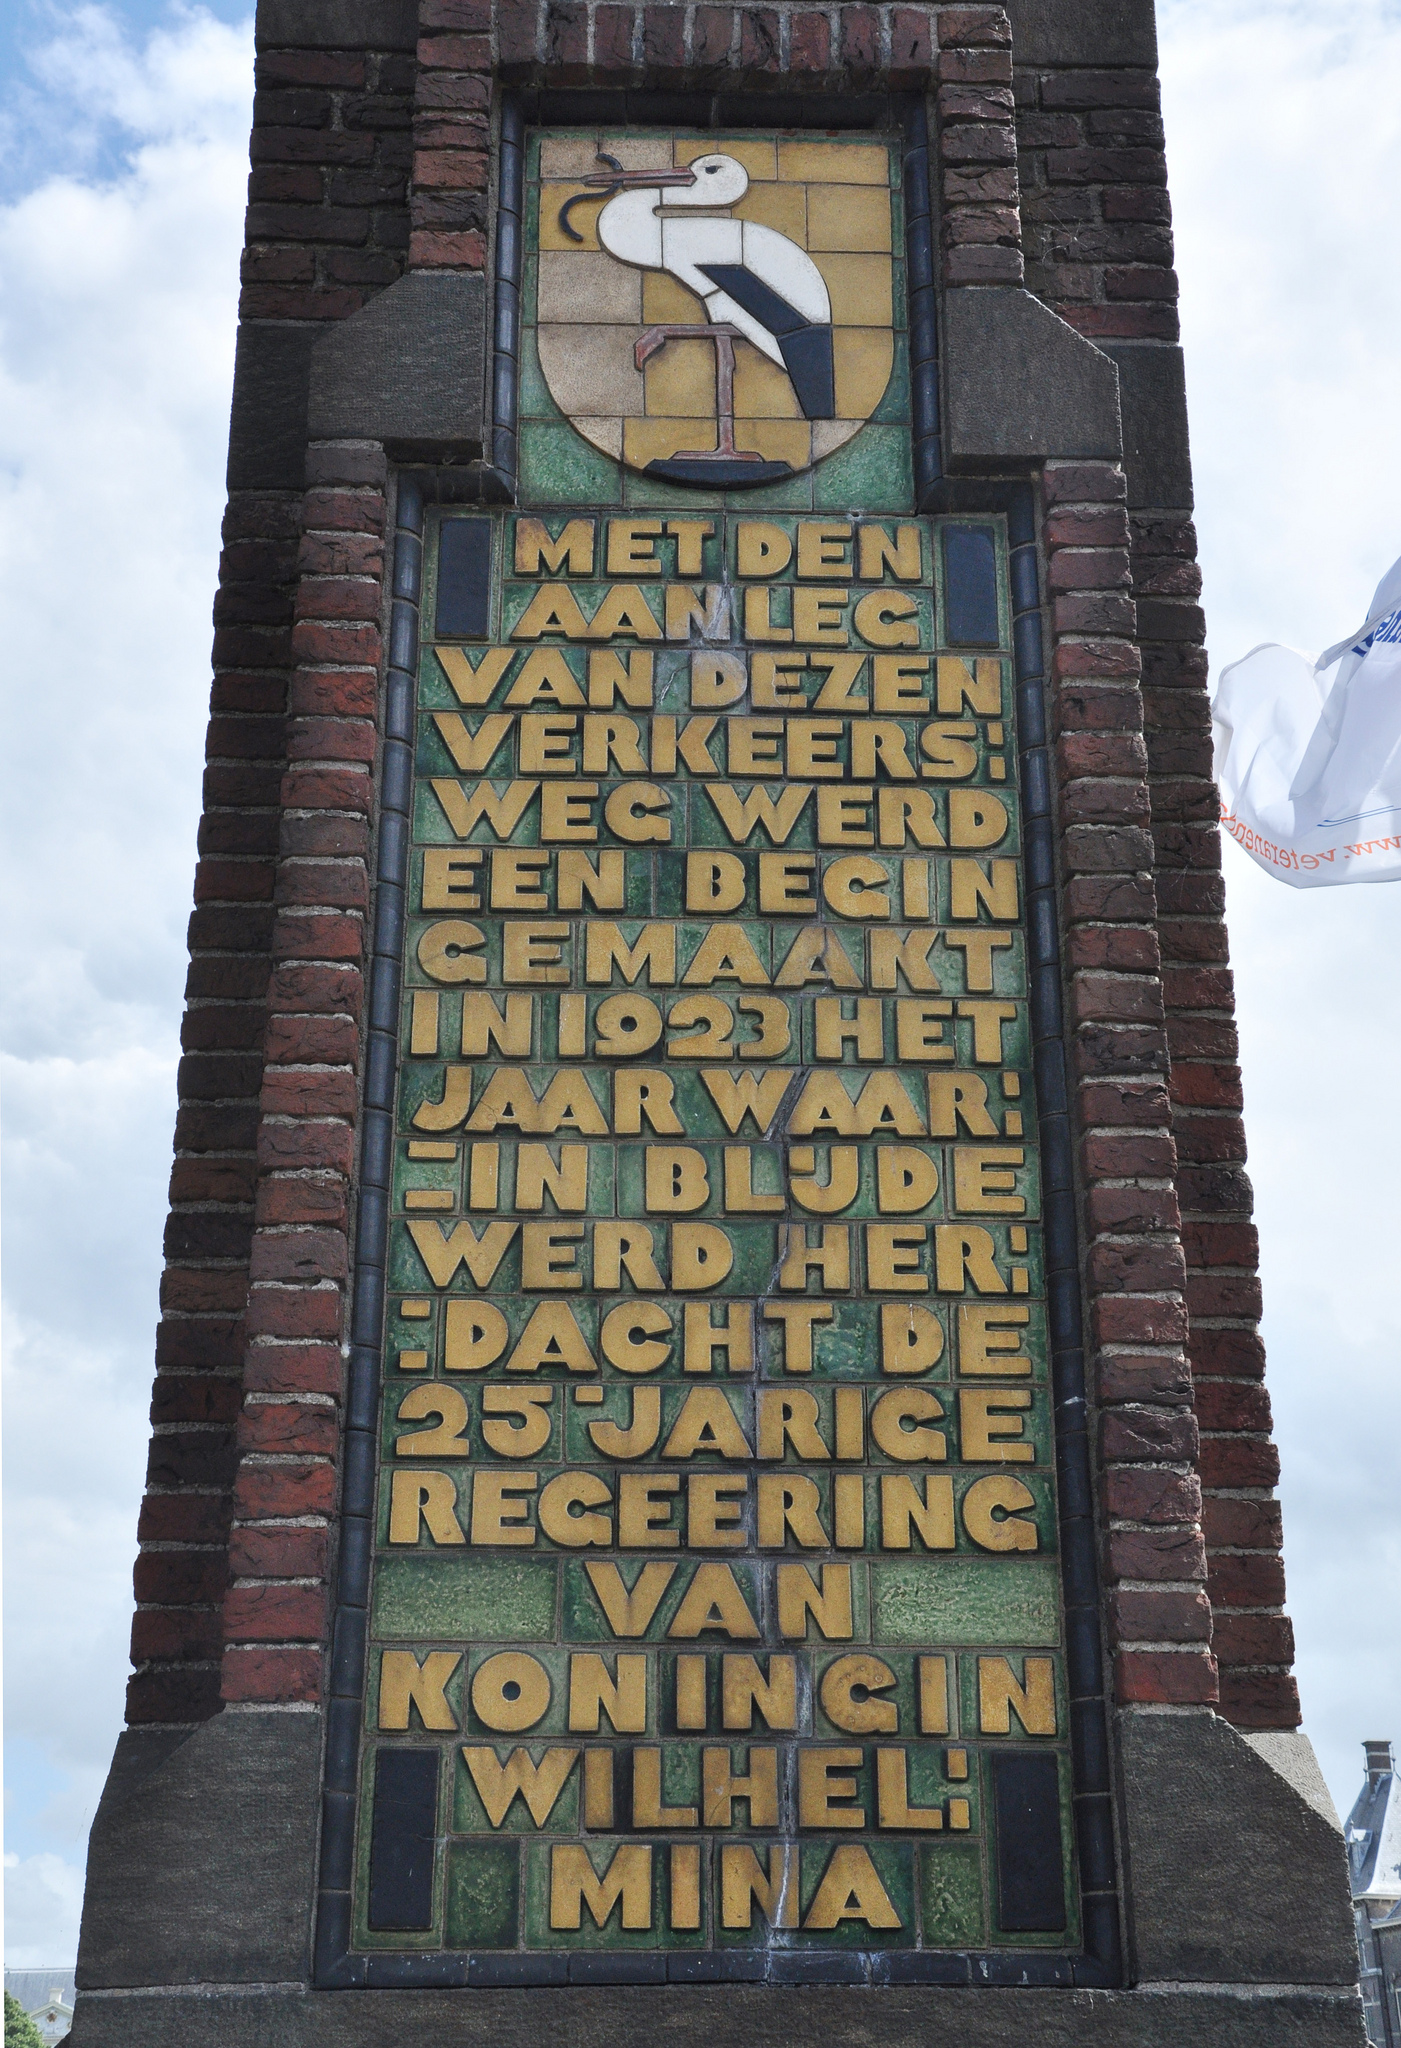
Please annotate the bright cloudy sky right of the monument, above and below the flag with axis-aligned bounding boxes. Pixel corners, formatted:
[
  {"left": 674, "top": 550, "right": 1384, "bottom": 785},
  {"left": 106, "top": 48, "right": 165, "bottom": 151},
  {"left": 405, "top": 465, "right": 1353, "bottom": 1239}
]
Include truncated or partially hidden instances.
[{"left": 1159, "top": 0, "right": 1401, "bottom": 1810}]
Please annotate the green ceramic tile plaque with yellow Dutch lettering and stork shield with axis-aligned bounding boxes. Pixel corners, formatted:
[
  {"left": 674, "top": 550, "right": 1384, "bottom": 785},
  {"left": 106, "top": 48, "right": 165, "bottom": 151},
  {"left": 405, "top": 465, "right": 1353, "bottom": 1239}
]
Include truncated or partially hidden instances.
[{"left": 352, "top": 131, "right": 1079, "bottom": 1982}]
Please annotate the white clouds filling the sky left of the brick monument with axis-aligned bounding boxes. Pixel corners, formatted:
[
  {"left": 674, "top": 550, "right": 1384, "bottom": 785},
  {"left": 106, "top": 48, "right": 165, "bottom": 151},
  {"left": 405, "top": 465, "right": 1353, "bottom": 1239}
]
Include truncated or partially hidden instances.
[{"left": 0, "top": 8, "right": 252, "bottom": 1964}]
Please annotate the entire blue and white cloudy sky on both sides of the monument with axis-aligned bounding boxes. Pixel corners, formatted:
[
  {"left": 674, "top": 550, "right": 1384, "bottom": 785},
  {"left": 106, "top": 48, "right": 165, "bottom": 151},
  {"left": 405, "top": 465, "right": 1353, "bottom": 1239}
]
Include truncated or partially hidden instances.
[{"left": 0, "top": 0, "right": 1401, "bottom": 1966}]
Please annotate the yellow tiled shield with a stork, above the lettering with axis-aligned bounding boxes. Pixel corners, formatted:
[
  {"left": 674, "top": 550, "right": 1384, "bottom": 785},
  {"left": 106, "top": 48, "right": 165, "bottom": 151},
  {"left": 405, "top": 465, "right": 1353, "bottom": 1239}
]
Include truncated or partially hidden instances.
[{"left": 526, "top": 131, "right": 899, "bottom": 489}]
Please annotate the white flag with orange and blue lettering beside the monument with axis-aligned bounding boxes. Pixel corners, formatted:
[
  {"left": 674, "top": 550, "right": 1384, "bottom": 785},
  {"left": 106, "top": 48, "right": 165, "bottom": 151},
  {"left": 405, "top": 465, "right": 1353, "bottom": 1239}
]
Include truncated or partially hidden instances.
[{"left": 1211, "top": 561, "right": 1401, "bottom": 889}]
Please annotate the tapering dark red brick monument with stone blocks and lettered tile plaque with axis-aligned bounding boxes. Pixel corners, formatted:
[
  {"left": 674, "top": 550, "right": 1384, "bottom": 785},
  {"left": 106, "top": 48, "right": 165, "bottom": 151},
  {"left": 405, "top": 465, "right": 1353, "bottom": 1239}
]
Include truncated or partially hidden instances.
[{"left": 72, "top": 0, "right": 1362, "bottom": 2048}]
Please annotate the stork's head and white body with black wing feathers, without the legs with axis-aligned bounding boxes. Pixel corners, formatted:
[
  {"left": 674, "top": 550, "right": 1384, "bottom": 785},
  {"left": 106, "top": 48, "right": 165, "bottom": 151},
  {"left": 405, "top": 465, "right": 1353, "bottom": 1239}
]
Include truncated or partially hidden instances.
[{"left": 559, "top": 152, "right": 836, "bottom": 420}]
